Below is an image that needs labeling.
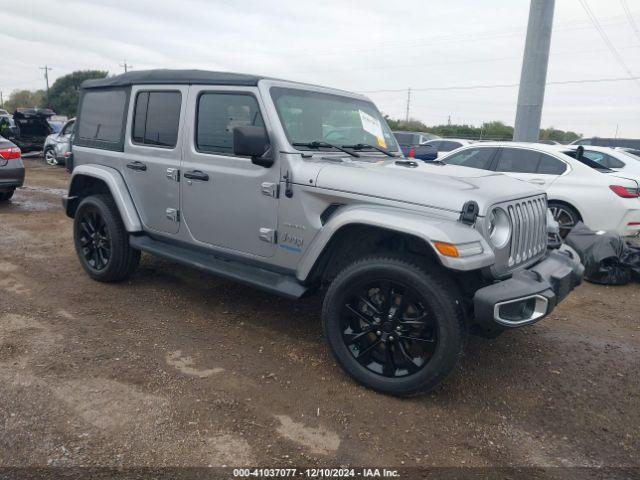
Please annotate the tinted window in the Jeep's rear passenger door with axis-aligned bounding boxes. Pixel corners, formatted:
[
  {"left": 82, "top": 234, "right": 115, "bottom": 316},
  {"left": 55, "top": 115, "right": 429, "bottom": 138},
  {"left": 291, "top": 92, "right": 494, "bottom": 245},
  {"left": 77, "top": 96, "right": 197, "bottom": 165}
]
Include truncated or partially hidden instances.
[{"left": 131, "top": 92, "right": 182, "bottom": 148}]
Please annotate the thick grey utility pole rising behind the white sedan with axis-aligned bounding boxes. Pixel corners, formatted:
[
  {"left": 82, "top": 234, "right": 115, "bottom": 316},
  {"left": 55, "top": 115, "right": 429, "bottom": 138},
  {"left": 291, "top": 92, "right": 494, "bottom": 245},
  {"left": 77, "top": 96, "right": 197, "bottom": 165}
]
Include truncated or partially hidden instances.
[{"left": 513, "top": 0, "right": 555, "bottom": 142}]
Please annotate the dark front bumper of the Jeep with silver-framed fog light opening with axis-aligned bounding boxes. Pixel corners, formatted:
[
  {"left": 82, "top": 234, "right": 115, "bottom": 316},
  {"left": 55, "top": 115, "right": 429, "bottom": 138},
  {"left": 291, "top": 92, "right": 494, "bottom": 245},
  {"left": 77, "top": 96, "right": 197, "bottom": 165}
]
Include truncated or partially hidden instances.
[{"left": 473, "top": 245, "right": 584, "bottom": 328}]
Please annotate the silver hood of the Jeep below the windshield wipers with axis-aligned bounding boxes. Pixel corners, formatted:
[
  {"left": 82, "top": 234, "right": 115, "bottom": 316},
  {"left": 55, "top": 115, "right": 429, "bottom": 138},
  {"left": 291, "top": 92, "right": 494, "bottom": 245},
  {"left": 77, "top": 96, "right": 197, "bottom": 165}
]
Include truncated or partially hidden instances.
[{"left": 316, "top": 157, "right": 544, "bottom": 215}]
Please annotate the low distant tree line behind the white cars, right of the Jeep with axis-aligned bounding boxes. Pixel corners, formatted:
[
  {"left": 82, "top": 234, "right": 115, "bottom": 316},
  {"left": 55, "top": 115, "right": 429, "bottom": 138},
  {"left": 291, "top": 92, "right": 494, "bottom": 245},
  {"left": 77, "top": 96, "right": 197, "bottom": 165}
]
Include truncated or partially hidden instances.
[{"left": 385, "top": 115, "right": 582, "bottom": 143}]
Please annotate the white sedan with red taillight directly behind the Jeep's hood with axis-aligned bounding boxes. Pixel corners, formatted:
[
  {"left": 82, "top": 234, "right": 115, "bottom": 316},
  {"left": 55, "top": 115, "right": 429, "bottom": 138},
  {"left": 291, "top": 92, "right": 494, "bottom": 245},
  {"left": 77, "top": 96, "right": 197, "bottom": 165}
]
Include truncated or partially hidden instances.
[{"left": 441, "top": 142, "right": 640, "bottom": 236}]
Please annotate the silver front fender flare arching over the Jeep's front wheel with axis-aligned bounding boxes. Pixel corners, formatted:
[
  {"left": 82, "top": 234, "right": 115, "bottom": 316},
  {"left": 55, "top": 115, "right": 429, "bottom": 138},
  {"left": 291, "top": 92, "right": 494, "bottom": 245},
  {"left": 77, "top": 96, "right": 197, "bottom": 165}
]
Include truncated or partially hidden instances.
[{"left": 296, "top": 206, "right": 495, "bottom": 281}]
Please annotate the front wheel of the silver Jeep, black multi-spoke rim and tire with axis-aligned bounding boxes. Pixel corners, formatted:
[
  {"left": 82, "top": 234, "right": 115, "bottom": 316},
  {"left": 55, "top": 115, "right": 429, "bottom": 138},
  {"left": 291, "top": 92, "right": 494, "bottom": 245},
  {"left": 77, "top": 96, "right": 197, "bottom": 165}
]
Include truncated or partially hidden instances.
[{"left": 322, "top": 257, "right": 465, "bottom": 396}]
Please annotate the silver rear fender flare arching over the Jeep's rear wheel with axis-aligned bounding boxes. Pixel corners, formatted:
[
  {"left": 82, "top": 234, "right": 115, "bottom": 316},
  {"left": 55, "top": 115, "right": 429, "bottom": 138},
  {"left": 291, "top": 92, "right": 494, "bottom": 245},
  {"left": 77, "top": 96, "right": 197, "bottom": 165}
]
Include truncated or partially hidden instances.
[{"left": 63, "top": 165, "right": 142, "bottom": 232}]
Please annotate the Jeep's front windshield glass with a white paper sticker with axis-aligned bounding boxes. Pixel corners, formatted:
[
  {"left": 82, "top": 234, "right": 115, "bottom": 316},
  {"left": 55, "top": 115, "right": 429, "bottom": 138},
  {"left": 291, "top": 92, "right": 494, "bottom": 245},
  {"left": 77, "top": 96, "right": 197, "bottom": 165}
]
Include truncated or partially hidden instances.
[{"left": 271, "top": 87, "right": 398, "bottom": 153}]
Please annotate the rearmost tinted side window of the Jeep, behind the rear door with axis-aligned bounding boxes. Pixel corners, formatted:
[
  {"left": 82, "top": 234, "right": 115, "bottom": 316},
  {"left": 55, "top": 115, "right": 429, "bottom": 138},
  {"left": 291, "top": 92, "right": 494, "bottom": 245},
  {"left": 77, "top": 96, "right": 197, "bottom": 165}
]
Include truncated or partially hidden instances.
[{"left": 76, "top": 89, "right": 128, "bottom": 150}]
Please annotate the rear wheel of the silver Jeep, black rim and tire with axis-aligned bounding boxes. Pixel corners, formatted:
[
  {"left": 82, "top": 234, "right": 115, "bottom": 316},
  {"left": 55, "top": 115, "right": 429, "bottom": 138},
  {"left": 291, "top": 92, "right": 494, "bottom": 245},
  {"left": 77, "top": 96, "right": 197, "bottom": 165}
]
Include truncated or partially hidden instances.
[{"left": 73, "top": 195, "right": 140, "bottom": 282}]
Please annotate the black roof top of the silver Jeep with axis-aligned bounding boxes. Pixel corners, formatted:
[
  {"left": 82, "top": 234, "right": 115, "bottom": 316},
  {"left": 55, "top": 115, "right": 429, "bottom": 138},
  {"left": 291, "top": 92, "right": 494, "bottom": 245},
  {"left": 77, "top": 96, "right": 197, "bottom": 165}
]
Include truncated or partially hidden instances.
[{"left": 82, "top": 69, "right": 267, "bottom": 88}]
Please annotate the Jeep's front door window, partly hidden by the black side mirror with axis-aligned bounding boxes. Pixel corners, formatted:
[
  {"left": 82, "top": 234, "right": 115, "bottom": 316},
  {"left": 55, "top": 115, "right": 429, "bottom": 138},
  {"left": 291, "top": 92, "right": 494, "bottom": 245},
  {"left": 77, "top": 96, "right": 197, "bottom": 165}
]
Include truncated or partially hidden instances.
[{"left": 196, "top": 92, "right": 264, "bottom": 155}]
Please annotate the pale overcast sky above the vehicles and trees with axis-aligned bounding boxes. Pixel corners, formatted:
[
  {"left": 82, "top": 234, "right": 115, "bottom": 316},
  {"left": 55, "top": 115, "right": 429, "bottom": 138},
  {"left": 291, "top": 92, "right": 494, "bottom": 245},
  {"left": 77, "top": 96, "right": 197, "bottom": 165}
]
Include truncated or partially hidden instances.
[{"left": 0, "top": 0, "right": 640, "bottom": 138}]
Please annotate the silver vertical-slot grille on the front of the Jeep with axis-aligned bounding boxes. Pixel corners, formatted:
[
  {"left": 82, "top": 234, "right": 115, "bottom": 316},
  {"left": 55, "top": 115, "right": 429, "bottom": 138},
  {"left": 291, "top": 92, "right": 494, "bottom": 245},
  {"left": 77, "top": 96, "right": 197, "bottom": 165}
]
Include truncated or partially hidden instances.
[{"left": 503, "top": 196, "right": 547, "bottom": 268}]
